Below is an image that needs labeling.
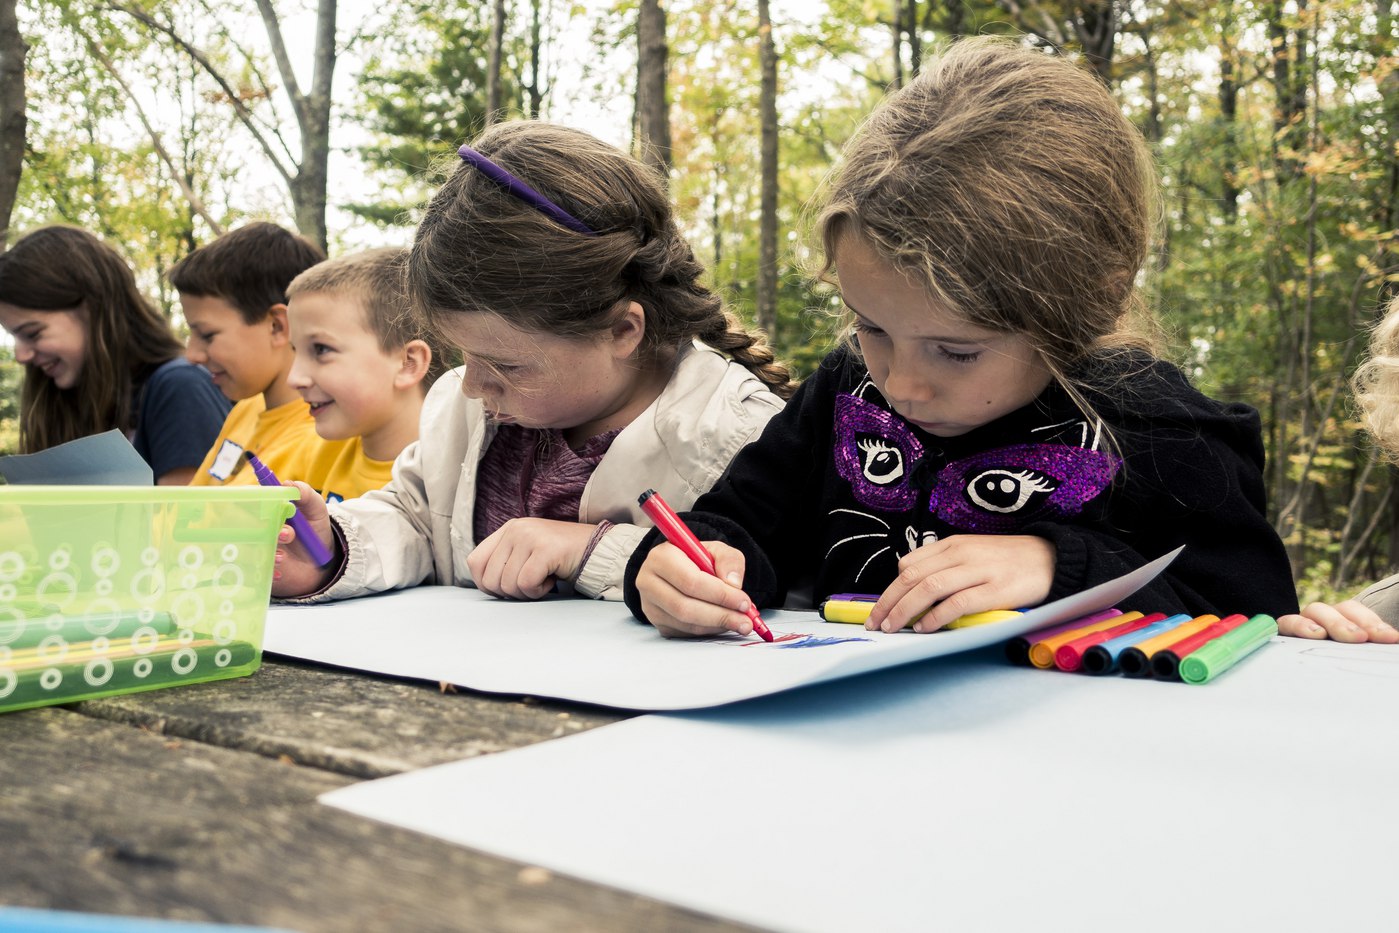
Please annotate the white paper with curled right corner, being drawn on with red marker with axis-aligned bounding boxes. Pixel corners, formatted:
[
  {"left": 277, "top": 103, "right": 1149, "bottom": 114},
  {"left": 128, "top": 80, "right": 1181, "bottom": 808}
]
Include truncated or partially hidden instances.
[{"left": 263, "top": 551, "right": 1178, "bottom": 709}]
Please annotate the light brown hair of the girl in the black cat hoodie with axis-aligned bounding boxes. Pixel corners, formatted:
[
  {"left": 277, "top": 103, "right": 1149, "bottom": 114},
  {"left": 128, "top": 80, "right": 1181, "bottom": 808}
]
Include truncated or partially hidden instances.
[{"left": 817, "top": 36, "right": 1156, "bottom": 406}]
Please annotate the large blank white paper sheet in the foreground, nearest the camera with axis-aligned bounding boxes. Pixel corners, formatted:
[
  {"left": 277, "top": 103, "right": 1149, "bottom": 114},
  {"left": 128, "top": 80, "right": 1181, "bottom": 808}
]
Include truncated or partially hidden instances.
[{"left": 322, "top": 639, "right": 1399, "bottom": 933}]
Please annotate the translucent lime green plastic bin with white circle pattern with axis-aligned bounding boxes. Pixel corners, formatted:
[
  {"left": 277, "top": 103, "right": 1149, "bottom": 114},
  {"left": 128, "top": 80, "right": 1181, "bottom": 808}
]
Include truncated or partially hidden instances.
[{"left": 0, "top": 485, "right": 297, "bottom": 711}]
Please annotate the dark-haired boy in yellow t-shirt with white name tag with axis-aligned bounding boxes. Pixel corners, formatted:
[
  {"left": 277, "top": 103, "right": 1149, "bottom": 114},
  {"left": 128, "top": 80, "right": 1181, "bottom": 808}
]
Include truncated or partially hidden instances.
[{"left": 169, "top": 222, "right": 335, "bottom": 487}]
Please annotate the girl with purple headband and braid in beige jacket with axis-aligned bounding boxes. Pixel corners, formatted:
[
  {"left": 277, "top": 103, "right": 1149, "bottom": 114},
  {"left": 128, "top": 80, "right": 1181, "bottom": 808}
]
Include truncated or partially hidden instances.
[{"left": 273, "top": 122, "right": 790, "bottom": 599}]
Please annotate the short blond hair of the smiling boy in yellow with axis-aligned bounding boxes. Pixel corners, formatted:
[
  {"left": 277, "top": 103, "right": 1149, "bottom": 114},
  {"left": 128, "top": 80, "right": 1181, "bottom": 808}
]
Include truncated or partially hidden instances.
[{"left": 287, "top": 246, "right": 448, "bottom": 390}]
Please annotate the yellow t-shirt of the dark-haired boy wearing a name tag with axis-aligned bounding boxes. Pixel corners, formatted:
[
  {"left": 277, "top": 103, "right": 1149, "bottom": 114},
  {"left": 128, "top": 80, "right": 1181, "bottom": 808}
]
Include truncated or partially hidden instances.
[{"left": 190, "top": 396, "right": 360, "bottom": 490}]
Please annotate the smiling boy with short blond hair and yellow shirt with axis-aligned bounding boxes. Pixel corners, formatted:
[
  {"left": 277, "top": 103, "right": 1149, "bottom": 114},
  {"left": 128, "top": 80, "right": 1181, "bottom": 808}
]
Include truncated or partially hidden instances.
[{"left": 279, "top": 248, "right": 445, "bottom": 502}]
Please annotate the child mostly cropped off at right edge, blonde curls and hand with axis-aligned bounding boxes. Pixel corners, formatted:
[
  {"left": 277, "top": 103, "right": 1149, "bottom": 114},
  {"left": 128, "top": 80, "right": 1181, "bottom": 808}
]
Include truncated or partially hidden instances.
[{"left": 1277, "top": 299, "right": 1399, "bottom": 645}]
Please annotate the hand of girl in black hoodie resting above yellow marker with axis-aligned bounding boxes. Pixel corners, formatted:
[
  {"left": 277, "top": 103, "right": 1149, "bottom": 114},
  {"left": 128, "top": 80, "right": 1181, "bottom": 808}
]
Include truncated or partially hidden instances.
[{"left": 865, "top": 534, "right": 1055, "bottom": 632}]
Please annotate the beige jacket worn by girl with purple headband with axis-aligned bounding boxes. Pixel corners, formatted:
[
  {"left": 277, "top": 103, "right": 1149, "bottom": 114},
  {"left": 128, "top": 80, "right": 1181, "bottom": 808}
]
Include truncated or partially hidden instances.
[{"left": 320, "top": 343, "right": 782, "bottom": 600}]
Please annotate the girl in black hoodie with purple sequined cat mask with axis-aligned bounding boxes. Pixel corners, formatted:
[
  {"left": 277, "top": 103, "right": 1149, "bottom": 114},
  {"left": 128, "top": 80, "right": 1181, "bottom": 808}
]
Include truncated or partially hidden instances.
[{"left": 625, "top": 39, "right": 1295, "bottom": 635}]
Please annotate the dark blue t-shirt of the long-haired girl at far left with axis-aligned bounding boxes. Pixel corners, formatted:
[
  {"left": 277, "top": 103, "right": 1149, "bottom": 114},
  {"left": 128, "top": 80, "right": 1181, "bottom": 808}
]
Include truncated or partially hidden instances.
[{"left": 132, "top": 357, "right": 232, "bottom": 480}]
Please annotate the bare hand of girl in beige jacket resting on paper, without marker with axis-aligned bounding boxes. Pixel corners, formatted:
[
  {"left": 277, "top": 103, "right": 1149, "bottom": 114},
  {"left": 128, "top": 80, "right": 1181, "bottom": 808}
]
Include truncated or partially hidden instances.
[{"left": 466, "top": 519, "right": 597, "bottom": 599}]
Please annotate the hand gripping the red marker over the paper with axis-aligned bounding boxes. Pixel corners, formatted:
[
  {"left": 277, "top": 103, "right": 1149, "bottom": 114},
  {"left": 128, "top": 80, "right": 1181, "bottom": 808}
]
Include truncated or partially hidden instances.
[{"left": 637, "top": 541, "right": 753, "bottom": 638}]
